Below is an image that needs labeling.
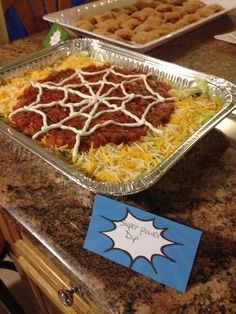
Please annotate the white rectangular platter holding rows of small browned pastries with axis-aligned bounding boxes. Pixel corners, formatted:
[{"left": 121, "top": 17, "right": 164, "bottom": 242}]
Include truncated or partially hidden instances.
[{"left": 43, "top": 0, "right": 236, "bottom": 52}]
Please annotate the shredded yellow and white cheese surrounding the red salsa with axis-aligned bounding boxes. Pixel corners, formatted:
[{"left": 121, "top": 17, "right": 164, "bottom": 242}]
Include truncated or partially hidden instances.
[{"left": 0, "top": 55, "right": 222, "bottom": 184}]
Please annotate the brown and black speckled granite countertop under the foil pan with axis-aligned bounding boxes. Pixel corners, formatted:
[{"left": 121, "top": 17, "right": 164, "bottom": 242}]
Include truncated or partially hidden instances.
[{"left": 0, "top": 9, "right": 236, "bottom": 314}]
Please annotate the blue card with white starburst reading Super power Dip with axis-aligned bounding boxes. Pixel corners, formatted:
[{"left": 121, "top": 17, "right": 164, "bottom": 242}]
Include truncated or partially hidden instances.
[{"left": 84, "top": 195, "right": 202, "bottom": 292}]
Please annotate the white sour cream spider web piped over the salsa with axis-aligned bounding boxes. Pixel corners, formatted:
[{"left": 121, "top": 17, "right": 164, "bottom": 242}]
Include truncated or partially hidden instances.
[{"left": 9, "top": 66, "right": 173, "bottom": 161}]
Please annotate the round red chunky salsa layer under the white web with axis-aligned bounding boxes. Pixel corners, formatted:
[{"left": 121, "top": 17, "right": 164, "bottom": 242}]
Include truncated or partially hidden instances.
[{"left": 10, "top": 65, "right": 175, "bottom": 151}]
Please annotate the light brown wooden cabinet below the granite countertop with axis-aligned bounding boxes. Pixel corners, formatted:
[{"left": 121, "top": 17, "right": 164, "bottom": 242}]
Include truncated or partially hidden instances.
[{"left": 0, "top": 212, "right": 102, "bottom": 314}]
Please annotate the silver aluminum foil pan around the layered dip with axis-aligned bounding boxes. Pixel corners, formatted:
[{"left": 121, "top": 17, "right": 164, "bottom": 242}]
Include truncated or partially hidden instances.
[{"left": 0, "top": 38, "right": 236, "bottom": 195}]
